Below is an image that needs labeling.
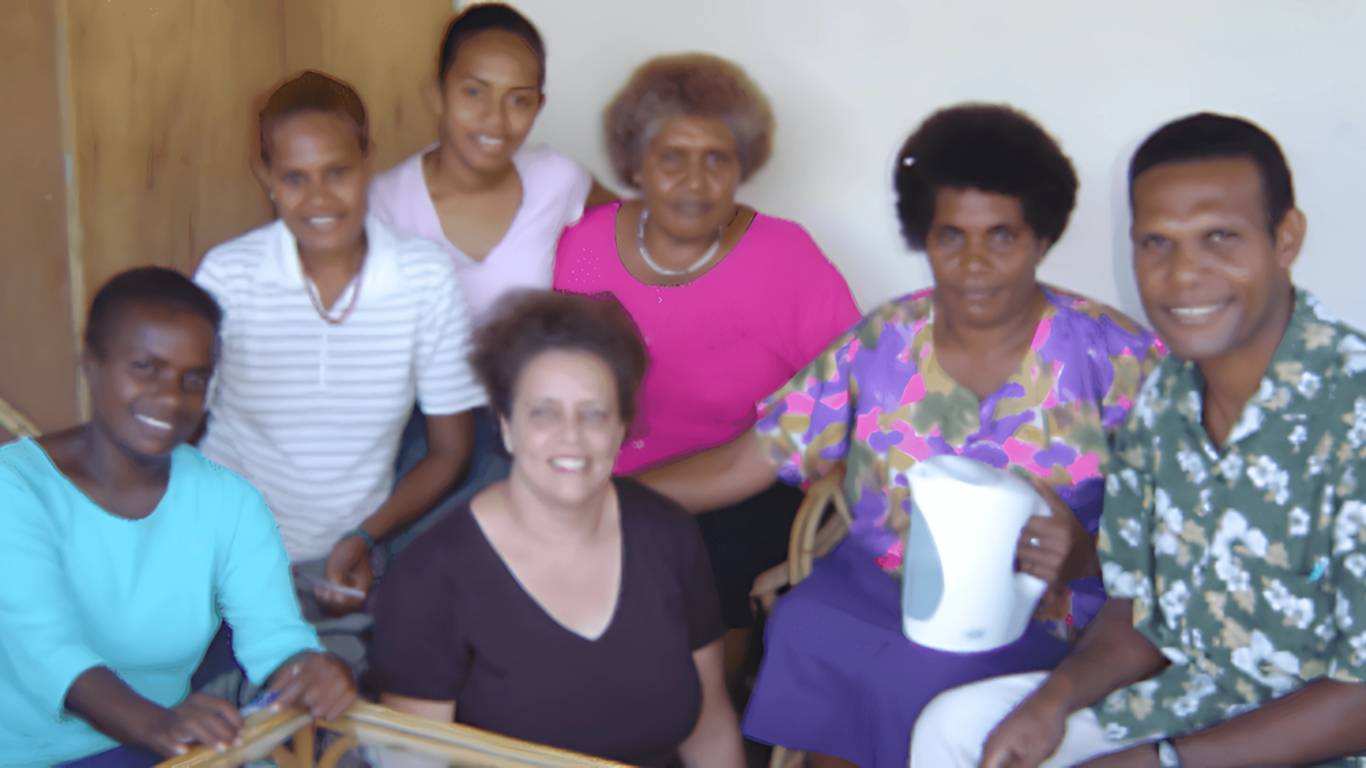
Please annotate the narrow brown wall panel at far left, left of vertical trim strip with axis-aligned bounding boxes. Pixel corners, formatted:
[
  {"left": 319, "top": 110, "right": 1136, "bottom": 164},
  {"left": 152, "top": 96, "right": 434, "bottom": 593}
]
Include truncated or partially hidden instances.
[{"left": 0, "top": 0, "right": 76, "bottom": 431}]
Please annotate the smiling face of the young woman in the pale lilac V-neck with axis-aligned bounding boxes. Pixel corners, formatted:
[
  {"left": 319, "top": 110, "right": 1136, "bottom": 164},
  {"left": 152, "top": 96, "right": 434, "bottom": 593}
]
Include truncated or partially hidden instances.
[{"left": 437, "top": 30, "right": 545, "bottom": 174}]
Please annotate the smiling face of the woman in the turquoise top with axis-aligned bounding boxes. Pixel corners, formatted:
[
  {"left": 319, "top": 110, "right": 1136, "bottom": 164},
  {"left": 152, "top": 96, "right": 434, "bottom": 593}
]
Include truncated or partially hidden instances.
[{"left": 82, "top": 303, "right": 216, "bottom": 461}]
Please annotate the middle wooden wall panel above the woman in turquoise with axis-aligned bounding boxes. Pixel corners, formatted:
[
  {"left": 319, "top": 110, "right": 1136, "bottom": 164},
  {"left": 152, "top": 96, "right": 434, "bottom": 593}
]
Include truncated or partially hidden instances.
[{"left": 70, "top": 0, "right": 284, "bottom": 294}]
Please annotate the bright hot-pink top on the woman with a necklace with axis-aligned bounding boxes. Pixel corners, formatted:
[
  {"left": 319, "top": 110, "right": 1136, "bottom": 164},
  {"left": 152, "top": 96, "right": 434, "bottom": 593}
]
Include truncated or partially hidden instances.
[{"left": 555, "top": 202, "right": 859, "bottom": 473}]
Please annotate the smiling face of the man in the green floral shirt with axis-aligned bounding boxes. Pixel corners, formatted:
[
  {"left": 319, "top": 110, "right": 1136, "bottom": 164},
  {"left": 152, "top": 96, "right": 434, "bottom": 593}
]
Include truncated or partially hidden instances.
[{"left": 1131, "top": 159, "right": 1305, "bottom": 362}]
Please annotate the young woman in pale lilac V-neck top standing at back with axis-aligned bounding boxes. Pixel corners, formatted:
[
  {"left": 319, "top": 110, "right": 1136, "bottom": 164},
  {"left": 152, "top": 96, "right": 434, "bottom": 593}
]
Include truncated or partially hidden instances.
[{"left": 370, "top": 3, "right": 616, "bottom": 551}]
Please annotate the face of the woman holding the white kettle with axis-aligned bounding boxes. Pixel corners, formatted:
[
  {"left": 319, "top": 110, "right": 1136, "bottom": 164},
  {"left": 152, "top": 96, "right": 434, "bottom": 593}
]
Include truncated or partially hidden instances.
[{"left": 925, "top": 187, "right": 1049, "bottom": 327}]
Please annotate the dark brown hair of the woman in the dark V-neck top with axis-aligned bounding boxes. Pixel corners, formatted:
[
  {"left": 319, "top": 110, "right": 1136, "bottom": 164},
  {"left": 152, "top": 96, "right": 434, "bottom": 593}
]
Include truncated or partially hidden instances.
[{"left": 470, "top": 290, "right": 647, "bottom": 425}]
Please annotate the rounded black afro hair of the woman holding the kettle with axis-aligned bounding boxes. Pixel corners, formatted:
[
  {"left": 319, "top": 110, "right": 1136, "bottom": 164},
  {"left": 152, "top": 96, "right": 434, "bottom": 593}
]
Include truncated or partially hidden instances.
[{"left": 892, "top": 104, "right": 1076, "bottom": 250}]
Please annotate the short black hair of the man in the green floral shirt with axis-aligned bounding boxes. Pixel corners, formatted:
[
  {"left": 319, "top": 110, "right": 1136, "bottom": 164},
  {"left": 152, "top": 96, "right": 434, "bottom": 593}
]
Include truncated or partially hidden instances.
[{"left": 1128, "top": 112, "right": 1295, "bottom": 234}]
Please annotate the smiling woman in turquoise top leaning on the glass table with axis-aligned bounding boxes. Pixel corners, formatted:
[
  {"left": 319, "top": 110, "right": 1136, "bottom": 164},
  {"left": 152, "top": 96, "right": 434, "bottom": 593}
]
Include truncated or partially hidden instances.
[{"left": 0, "top": 268, "right": 355, "bottom": 765}]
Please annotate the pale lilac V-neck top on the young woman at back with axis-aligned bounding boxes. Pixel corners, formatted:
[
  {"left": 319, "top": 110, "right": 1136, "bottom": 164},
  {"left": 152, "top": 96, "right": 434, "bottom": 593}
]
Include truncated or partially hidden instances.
[{"left": 370, "top": 146, "right": 593, "bottom": 325}]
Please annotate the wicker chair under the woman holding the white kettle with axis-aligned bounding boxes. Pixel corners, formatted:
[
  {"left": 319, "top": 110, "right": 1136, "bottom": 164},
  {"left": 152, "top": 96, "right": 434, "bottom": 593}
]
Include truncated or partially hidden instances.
[{"left": 750, "top": 465, "right": 852, "bottom": 768}]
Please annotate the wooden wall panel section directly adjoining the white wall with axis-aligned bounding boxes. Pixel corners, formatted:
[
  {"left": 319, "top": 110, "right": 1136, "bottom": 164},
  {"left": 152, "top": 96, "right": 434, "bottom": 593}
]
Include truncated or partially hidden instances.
[{"left": 283, "top": 0, "right": 452, "bottom": 171}]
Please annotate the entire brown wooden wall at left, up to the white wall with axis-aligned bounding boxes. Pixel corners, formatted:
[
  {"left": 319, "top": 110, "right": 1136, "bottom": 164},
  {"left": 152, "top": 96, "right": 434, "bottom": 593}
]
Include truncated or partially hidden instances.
[{"left": 0, "top": 0, "right": 452, "bottom": 439}]
